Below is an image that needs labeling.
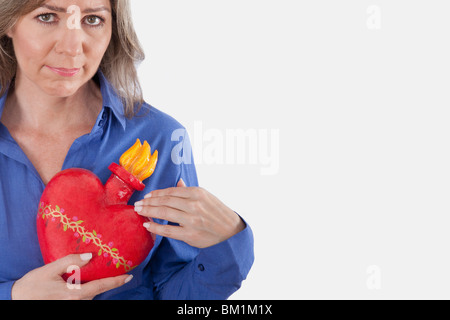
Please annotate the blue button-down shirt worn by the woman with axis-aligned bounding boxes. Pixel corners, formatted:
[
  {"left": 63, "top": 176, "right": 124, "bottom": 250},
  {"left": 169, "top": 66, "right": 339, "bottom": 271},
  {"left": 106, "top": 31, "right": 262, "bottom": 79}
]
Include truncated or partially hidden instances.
[{"left": 0, "top": 71, "right": 253, "bottom": 299}]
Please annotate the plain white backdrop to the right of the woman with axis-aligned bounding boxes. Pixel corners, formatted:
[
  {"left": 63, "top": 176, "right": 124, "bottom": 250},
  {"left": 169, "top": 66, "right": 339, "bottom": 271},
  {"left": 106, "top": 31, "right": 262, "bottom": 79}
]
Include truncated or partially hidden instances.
[{"left": 132, "top": 0, "right": 450, "bottom": 299}]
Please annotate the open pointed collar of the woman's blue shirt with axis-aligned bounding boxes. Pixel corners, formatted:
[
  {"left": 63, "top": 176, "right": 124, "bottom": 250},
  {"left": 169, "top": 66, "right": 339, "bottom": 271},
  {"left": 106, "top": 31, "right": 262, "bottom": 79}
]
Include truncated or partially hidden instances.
[{"left": 0, "top": 69, "right": 127, "bottom": 130}]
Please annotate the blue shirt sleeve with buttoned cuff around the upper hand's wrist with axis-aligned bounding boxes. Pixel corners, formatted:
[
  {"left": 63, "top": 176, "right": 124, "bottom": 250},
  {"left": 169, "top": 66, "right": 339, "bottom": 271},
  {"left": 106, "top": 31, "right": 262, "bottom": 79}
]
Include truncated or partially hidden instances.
[{"left": 150, "top": 220, "right": 254, "bottom": 300}]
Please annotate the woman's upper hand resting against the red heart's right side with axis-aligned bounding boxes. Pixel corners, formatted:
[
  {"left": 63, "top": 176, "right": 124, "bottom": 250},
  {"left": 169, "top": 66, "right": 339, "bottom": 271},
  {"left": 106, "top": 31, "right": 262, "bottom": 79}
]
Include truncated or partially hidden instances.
[{"left": 135, "top": 180, "right": 245, "bottom": 248}]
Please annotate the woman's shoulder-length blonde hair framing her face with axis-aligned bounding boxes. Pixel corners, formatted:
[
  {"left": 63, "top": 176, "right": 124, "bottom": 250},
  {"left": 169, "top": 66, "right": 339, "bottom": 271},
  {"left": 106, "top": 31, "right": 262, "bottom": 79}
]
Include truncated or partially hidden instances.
[{"left": 0, "top": 0, "right": 145, "bottom": 118}]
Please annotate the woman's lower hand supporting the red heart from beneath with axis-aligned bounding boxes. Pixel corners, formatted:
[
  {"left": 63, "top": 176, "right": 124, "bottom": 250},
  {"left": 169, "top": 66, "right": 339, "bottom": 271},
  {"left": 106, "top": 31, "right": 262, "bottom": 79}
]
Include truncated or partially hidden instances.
[{"left": 11, "top": 253, "right": 133, "bottom": 300}]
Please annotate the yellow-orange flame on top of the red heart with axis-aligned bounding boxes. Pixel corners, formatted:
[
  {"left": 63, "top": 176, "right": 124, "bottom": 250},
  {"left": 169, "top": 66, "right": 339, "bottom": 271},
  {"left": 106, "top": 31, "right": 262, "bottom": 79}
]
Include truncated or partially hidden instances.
[{"left": 120, "top": 139, "right": 158, "bottom": 181}]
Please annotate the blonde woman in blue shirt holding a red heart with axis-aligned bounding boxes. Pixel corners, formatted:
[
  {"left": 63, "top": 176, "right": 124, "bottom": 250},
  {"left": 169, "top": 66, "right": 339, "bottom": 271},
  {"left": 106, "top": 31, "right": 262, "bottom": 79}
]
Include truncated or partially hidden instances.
[{"left": 0, "top": 0, "right": 253, "bottom": 299}]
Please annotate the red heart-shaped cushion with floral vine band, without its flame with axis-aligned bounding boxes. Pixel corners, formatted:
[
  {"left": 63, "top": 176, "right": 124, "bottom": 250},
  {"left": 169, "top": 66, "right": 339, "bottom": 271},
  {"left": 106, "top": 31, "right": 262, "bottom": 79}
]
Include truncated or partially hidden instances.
[{"left": 37, "top": 164, "right": 153, "bottom": 282}]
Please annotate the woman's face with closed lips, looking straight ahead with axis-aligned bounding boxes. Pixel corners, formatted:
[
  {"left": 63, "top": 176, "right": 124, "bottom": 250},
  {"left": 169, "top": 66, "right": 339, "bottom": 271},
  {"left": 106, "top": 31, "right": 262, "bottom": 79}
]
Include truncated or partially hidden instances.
[{"left": 8, "top": 0, "right": 112, "bottom": 97}]
